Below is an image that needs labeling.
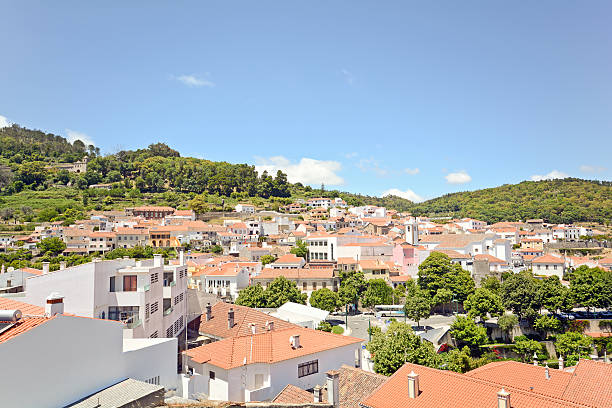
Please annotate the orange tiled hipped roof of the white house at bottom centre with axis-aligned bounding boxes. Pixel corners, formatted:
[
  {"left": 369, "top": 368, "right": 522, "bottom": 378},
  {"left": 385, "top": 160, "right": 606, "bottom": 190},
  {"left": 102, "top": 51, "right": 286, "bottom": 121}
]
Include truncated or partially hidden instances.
[{"left": 184, "top": 327, "right": 363, "bottom": 370}]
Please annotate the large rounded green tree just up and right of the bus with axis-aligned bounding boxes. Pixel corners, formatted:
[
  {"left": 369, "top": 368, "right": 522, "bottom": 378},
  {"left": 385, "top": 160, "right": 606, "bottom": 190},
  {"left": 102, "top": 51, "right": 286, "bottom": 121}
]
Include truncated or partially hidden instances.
[{"left": 418, "top": 252, "right": 475, "bottom": 302}]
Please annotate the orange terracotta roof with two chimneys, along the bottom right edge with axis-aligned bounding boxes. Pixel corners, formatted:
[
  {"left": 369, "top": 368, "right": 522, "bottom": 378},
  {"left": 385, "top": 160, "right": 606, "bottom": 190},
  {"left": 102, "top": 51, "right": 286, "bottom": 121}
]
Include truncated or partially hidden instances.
[{"left": 362, "top": 363, "right": 606, "bottom": 408}]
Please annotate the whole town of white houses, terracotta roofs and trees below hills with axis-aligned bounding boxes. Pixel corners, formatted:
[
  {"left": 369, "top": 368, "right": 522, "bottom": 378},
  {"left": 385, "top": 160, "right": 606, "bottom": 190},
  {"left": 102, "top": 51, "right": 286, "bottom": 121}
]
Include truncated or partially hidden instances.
[{"left": 0, "top": 202, "right": 612, "bottom": 408}]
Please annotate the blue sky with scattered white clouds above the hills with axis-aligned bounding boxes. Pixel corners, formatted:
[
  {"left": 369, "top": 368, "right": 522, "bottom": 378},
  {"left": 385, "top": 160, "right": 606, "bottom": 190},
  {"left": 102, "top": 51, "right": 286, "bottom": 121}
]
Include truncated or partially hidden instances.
[{"left": 0, "top": 0, "right": 612, "bottom": 201}]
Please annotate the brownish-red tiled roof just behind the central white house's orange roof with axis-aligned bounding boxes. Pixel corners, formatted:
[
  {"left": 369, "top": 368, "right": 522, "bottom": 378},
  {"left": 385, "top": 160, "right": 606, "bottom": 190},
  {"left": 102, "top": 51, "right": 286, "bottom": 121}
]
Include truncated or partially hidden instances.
[{"left": 199, "top": 302, "right": 298, "bottom": 339}]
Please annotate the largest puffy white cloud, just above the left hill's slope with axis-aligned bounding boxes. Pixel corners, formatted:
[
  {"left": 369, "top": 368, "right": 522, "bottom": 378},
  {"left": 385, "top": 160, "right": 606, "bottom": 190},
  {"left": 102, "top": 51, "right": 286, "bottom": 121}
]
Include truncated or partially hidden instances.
[{"left": 255, "top": 156, "right": 344, "bottom": 186}]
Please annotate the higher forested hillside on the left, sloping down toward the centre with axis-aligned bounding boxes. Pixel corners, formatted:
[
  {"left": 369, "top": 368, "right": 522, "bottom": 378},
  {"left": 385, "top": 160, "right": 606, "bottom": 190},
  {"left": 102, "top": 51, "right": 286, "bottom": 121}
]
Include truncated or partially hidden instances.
[{"left": 0, "top": 125, "right": 412, "bottom": 212}]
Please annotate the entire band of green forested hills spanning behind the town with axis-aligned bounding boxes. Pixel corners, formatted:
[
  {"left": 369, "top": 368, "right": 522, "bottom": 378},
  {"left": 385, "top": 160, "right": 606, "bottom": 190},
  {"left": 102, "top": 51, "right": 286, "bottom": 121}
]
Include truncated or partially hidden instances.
[{"left": 0, "top": 125, "right": 612, "bottom": 223}]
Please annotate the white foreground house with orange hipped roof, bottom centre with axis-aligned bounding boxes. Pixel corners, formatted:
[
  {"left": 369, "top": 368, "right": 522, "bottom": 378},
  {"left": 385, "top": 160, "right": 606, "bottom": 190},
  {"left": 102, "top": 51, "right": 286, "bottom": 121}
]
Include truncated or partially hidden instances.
[{"left": 183, "top": 326, "right": 363, "bottom": 401}]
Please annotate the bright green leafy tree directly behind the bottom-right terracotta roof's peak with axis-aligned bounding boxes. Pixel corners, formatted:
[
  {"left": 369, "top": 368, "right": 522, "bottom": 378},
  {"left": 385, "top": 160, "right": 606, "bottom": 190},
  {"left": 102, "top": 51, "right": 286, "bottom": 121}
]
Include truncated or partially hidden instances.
[{"left": 366, "top": 321, "right": 438, "bottom": 375}]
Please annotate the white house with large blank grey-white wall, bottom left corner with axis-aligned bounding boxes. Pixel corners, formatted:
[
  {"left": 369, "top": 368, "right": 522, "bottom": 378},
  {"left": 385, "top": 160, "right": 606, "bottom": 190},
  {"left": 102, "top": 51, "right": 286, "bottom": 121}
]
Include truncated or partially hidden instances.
[{"left": 0, "top": 296, "right": 178, "bottom": 408}]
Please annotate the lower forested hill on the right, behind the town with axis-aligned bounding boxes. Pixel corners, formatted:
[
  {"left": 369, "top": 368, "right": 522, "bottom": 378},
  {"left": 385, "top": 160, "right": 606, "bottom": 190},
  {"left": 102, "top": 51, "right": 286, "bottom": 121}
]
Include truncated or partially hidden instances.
[{"left": 412, "top": 178, "right": 612, "bottom": 223}]
